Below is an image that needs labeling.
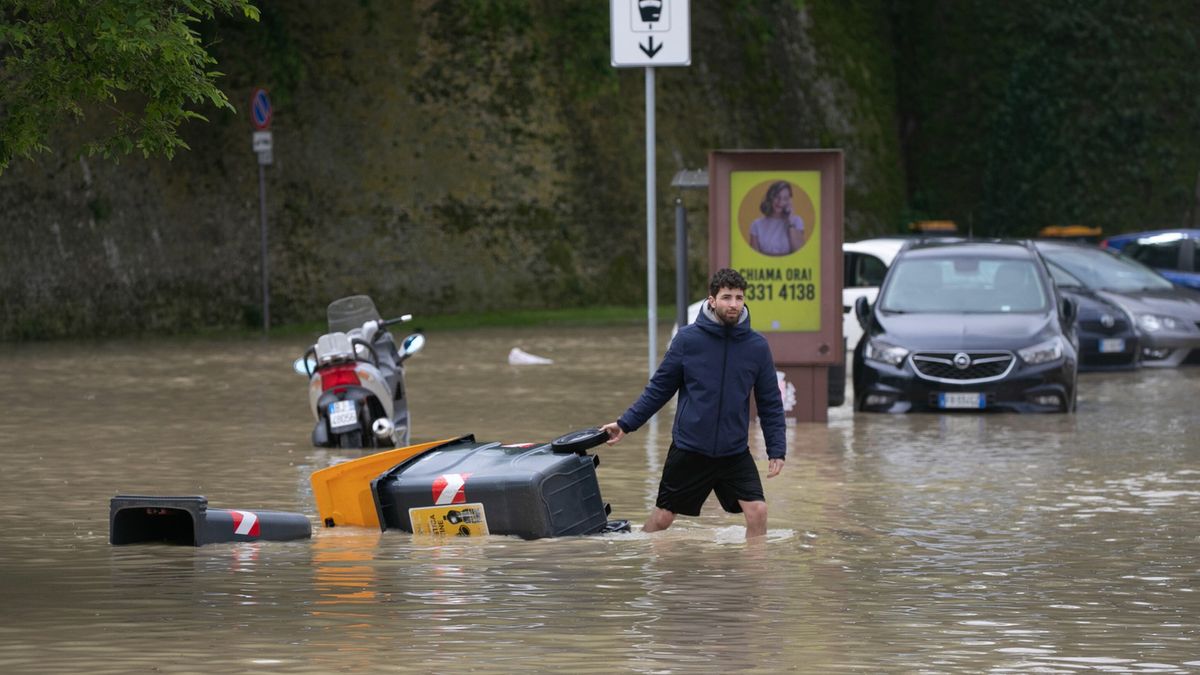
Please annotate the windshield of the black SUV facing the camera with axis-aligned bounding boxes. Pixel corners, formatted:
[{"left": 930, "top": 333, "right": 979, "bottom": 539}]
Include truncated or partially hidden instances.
[{"left": 880, "top": 257, "right": 1048, "bottom": 313}]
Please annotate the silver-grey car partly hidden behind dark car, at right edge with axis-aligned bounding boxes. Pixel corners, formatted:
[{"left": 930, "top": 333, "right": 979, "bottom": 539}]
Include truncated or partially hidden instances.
[{"left": 1037, "top": 241, "right": 1200, "bottom": 368}]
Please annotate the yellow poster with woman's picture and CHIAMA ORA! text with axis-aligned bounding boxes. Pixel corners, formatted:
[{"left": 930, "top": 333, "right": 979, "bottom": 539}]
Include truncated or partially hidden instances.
[{"left": 730, "top": 171, "right": 821, "bottom": 333}]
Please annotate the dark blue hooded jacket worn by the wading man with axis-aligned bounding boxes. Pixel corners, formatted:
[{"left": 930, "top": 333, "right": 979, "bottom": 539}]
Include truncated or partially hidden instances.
[{"left": 617, "top": 304, "right": 787, "bottom": 459}]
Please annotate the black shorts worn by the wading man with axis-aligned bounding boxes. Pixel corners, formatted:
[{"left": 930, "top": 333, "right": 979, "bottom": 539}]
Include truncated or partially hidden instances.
[{"left": 655, "top": 443, "right": 766, "bottom": 515}]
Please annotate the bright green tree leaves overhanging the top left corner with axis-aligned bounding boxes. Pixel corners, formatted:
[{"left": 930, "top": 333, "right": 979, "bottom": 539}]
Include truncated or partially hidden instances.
[{"left": 0, "top": 0, "right": 258, "bottom": 172}]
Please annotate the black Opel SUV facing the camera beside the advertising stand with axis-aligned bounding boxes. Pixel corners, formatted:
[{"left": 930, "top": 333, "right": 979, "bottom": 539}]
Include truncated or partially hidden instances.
[{"left": 853, "top": 240, "right": 1079, "bottom": 412}]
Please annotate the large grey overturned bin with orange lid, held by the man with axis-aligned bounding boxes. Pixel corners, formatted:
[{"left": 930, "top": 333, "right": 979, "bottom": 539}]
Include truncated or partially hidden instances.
[{"left": 312, "top": 429, "right": 629, "bottom": 539}]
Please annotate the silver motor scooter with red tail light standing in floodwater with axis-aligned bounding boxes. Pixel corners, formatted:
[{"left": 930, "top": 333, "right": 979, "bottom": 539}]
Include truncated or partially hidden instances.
[{"left": 293, "top": 295, "right": 425, "bottom": 448}]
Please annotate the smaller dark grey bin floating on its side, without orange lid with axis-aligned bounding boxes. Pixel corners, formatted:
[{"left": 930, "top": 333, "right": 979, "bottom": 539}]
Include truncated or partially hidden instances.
[{"left": 108, "top": 495, "right": 312, "bottom": 546}]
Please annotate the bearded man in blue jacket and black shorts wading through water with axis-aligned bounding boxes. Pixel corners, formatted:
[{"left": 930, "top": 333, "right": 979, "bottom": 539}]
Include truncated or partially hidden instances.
[{"left": 601, "top": 269, "right": 787, "bottom": 539}]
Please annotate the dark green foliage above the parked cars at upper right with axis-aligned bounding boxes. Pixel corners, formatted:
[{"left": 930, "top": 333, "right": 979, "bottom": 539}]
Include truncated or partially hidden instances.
[{"left": 894, "top": 0, "right": 1200, "bottom": 237}]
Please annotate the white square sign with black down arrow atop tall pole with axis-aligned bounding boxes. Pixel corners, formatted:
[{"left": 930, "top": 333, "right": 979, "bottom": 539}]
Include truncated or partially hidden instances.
[{"left": 610, "top": 0, "right": 691, "bottom": 68}]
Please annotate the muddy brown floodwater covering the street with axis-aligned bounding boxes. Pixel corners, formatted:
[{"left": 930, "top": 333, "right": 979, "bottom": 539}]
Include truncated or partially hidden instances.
[{"left": 0, "top": 327, "right": 1200, "bottom": 674}]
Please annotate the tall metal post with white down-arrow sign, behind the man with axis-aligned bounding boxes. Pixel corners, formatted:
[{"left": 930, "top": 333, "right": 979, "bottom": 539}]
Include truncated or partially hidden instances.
[{"left": 610, "top": 0, "right": 691, "bottom": 376}]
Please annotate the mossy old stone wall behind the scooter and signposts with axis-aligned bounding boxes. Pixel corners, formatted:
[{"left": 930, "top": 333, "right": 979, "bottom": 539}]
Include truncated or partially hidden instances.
[{"left": 0, "top": 0, "right": 993, "bottom": 339}]
